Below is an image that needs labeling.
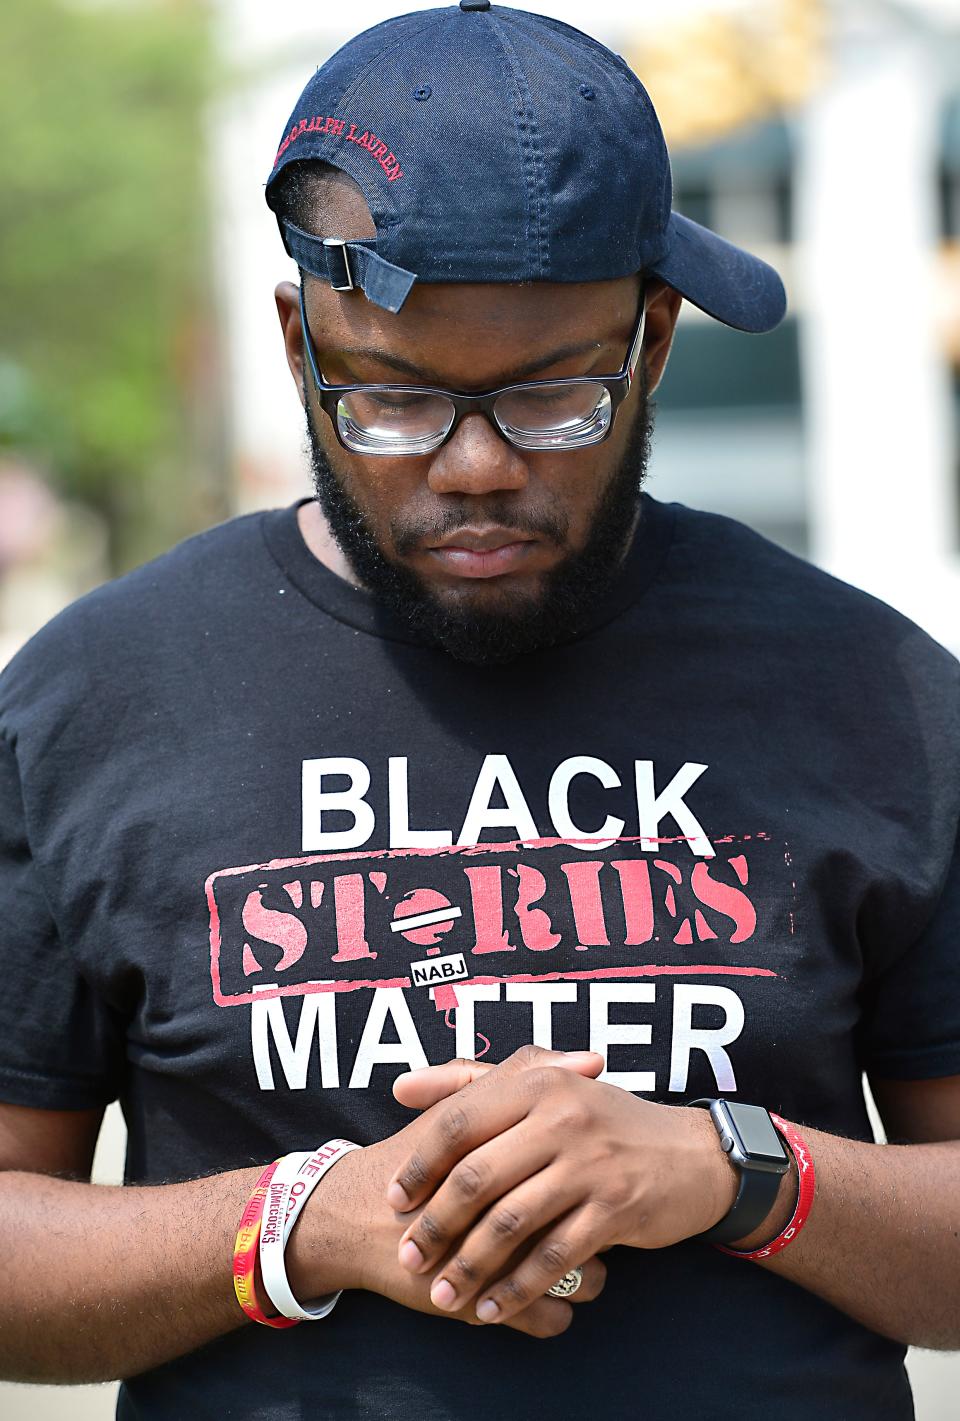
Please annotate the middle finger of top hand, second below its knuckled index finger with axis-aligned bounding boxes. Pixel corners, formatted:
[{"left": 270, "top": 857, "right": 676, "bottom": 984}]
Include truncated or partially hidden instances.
[{"left": 398, "top": 1121, "right": 560, "bottom": 1277}]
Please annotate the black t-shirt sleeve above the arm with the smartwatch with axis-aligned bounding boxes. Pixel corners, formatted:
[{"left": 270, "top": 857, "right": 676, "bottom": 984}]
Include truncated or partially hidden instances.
[{"left": 861, "top": 837, "right": 960, "bottom": 1080}]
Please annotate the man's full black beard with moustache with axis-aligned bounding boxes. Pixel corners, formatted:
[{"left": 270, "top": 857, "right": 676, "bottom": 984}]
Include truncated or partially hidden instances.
[{"left": 307, "top": 380, "right": 653, "bottom": 665}]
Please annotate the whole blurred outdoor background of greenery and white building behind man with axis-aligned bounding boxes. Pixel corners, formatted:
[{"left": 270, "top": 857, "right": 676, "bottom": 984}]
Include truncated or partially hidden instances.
[{"left": 0, "top": 0, "right": 960, "bottom": 1421}]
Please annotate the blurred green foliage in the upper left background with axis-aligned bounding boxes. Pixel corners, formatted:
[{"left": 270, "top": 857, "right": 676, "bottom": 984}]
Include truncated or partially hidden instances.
[{"left": 0, "top": 0, "right": 220, "bottom": 568}]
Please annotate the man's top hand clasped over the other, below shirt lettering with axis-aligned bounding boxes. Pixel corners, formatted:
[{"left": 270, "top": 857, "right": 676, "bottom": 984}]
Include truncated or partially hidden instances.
[{"left": 386, "top": 1047, "right": 736, "bottom": 1323}]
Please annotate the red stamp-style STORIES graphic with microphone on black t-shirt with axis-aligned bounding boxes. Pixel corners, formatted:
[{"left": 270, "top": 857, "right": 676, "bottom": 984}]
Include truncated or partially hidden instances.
[{"left": 206, "top": 834, "right": 775, "bottom": 1012}]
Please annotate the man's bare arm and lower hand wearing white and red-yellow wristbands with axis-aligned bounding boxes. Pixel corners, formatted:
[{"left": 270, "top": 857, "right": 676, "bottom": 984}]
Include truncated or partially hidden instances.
[{"left": 0, "top": 1068, "right": 605, "bottom": 1383}]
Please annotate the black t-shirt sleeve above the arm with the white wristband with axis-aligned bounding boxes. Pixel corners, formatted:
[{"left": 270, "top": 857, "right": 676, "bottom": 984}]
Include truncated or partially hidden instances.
[{"left": 0, "top": 735, "right": 124, "bottom": 1110}]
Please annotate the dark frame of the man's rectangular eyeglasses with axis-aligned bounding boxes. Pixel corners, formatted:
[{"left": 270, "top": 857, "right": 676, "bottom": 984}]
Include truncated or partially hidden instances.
[{"left": 300, "top": 280, "right": 646, "bottom": 459}]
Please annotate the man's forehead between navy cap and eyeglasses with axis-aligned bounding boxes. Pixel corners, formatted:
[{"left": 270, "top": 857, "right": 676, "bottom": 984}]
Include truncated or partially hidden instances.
[{"left": 304, "top": 277, "right": 639, "bottom": 384}]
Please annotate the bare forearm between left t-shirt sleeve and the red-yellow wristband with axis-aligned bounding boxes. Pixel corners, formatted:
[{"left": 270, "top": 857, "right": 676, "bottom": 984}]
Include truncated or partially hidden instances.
[{"left": 0, "top": 1104, "right": 308, "bottom": 1383}]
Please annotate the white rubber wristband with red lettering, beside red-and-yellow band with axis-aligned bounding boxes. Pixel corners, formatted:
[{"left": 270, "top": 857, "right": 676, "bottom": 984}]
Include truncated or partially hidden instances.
[{"left": 260, "top": 1140, "right": 361, "bottom": 1323}]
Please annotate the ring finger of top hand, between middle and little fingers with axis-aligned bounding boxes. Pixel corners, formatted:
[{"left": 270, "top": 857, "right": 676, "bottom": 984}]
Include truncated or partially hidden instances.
[{"left": 430, "top": 1165, "right": 594, "bottom": 1322}]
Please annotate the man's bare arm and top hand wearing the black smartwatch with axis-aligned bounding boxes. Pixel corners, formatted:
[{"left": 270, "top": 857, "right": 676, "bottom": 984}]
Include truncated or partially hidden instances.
[{"left": 392, "top": 1050, "right": 960, "bottom": 1349}]
